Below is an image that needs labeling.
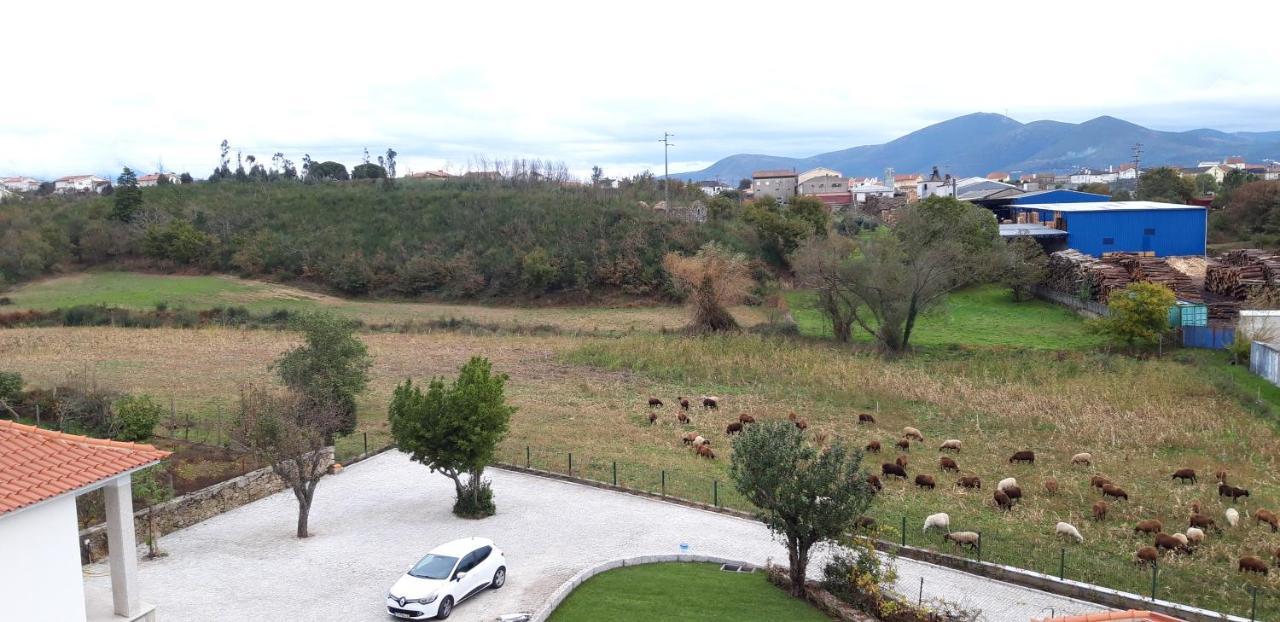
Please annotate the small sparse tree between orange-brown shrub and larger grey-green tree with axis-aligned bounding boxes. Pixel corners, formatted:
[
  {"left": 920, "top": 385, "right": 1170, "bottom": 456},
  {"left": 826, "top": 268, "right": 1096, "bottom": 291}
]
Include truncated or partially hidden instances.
[{"left": 791, "top": 235, "right": 859, "bottom": 343}]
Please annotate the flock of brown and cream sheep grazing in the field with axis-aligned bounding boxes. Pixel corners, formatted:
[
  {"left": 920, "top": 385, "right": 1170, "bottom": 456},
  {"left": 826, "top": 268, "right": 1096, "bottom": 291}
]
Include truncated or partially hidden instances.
[{"left": 649, "top": 395, "right": 1280, "bottom": 576}]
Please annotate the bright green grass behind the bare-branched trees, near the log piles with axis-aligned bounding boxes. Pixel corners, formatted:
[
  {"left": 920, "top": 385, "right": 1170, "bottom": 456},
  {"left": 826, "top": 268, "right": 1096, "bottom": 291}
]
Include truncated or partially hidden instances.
[{"left": 787, "top": 285, "right": 1102, "bottom": 349}]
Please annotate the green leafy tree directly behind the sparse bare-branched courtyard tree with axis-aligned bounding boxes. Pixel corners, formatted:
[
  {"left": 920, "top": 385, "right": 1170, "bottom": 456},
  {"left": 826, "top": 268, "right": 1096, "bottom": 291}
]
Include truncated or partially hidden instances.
[{"left": 273, "top": 312, "right": 372, "bottom": 438}]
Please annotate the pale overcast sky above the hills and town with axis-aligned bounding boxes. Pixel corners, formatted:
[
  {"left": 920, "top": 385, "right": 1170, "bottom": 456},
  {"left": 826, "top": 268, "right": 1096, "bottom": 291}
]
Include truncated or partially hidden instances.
[{"left": 0, "top": 0, "right": 1280, "bottom": 178}]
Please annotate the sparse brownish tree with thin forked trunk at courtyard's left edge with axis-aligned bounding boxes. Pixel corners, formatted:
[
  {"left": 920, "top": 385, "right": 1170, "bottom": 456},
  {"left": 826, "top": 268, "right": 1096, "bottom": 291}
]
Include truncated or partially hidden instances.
[{"left": 230, "top": 387, "right": 342, "bottom": 538}]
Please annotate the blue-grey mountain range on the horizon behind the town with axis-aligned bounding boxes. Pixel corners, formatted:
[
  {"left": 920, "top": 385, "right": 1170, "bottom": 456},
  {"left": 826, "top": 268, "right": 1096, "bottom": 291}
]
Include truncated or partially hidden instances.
[{"left": 673, "top": 113, "right": 1280, "bottom": 182}]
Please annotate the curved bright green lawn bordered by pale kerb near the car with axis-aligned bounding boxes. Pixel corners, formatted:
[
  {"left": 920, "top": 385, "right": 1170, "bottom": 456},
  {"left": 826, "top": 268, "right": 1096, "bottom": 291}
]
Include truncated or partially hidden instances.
[{"left": 550, "top": 563, "right": 827, "bottom": 622}]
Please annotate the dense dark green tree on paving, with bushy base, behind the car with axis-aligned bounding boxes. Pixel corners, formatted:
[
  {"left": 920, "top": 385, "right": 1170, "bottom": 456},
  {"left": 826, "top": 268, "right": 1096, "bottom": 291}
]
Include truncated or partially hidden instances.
[{"left": 387, "top": 357, "right": 516, "bottom": 518}]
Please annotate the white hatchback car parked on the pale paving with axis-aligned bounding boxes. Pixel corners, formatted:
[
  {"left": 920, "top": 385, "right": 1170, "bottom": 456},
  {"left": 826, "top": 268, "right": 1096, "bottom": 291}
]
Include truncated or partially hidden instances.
[{"left": 387, "top": 538, "right": 507, "bottom": 619}]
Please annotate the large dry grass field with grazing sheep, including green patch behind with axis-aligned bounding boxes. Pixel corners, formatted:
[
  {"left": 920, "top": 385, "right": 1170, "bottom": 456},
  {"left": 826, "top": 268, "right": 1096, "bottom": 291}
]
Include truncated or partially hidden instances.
[{"left": 0, "top": 272, "right": 1280, "bottom": 619}]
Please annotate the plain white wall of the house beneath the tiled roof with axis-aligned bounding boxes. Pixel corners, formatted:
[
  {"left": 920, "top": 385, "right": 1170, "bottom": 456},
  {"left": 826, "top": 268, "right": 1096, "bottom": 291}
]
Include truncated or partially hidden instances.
[{"left": 0, "top": 495, "right": 84, "bottom": 622}]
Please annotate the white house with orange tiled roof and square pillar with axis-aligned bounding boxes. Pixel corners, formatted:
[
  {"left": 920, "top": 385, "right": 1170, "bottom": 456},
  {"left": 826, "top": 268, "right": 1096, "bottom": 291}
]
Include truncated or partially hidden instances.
[{"left": 0, "top": 420, "right": 169, "bottom": 622}]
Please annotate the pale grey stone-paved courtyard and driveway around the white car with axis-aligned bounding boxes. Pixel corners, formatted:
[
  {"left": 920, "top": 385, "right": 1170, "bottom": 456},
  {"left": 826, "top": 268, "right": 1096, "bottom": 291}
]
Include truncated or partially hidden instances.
[{"left": 86, "top": 452, "right": 1100, "bottom": 622}]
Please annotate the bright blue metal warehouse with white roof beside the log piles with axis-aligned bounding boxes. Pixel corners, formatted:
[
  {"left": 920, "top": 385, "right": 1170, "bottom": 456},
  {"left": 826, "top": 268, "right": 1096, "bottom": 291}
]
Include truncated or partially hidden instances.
[{"left": 1010, "top": 201, "right": 1208, "bottom": 257}]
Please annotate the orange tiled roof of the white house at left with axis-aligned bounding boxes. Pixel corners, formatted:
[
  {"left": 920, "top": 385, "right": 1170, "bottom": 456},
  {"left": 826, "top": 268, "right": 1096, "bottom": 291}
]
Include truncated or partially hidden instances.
[{"left": 0, "top": 421, "right": 170, "bottom": 516}]
